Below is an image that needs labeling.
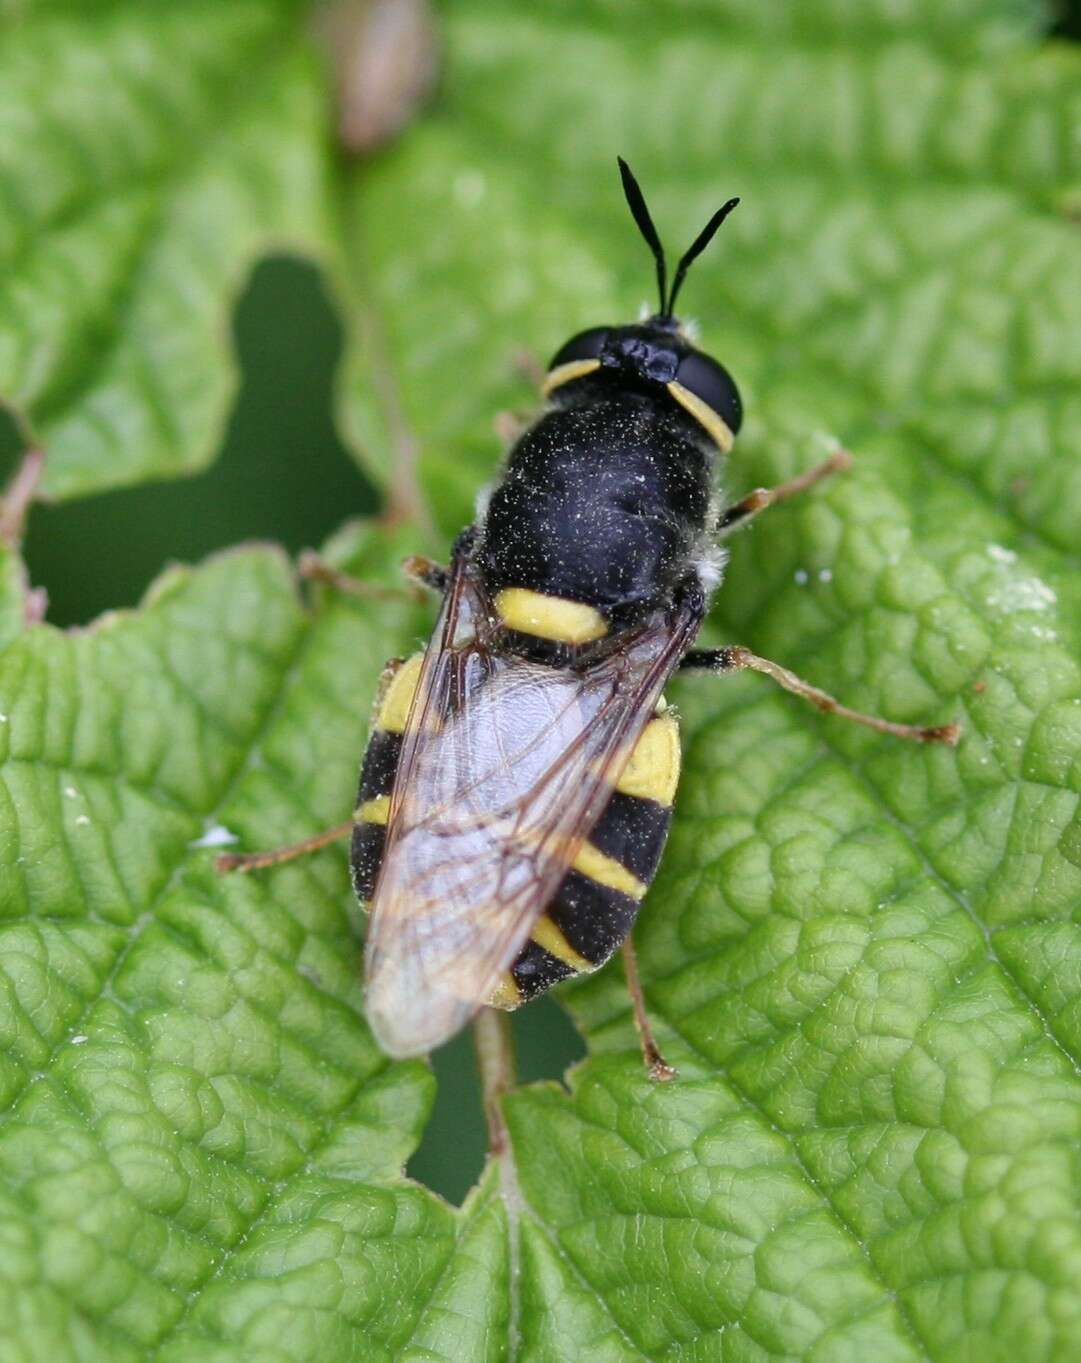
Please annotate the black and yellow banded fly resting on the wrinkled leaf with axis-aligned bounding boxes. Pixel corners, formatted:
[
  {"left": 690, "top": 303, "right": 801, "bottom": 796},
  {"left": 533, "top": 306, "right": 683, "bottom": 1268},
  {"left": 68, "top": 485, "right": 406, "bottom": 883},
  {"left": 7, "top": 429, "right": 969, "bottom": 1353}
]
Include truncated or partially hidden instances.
[{"left": 221, "top": 159, "right": 958, "bottom": 1077}]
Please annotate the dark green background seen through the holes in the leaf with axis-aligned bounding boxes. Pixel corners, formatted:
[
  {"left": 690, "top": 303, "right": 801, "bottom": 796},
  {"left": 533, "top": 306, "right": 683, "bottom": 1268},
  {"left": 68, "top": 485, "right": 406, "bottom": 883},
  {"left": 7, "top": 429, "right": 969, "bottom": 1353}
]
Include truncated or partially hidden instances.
[{"left": 0, "top": 0, "right": 1081, "bottom": 1201}]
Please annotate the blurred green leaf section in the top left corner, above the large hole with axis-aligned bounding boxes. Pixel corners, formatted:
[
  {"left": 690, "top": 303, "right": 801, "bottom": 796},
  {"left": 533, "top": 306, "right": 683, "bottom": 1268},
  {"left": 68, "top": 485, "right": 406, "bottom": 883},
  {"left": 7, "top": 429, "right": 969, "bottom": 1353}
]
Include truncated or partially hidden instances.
[{"left": 0, "top": 0, "right": 327, "bottom": 497}]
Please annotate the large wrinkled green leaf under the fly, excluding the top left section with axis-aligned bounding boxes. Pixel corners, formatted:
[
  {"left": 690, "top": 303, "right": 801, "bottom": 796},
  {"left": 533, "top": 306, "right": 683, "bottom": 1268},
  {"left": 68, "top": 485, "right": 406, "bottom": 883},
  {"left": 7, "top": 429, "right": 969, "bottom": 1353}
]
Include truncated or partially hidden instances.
[{"left": 0, "top": 0, "right": 1081, "bottom": 1363}]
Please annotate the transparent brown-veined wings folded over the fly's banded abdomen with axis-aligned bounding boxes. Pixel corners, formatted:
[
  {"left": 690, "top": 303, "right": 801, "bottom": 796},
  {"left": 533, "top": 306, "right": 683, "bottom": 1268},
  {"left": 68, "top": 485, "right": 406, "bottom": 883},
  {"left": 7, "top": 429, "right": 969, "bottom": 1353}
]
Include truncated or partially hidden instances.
[{"left": 365, "top": 559, "right": 697, "bottom": 1056}]
